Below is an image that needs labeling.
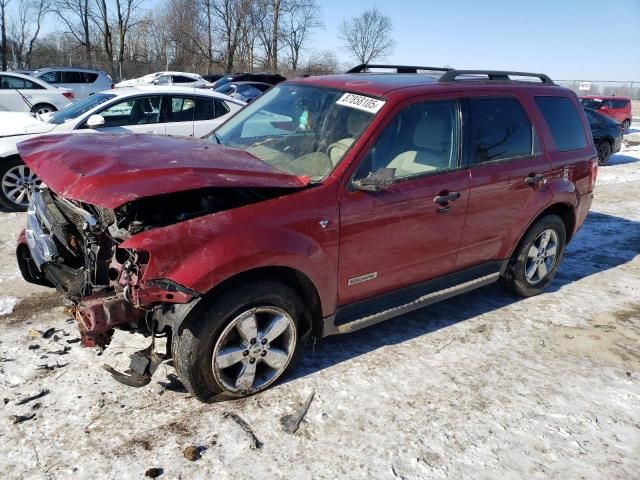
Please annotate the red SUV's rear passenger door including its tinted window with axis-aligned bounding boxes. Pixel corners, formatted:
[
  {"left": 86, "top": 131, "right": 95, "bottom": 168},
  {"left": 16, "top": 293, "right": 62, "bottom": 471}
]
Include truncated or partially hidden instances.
[{"left": 457, "top": 91, "right": 552, "bottom": 268}]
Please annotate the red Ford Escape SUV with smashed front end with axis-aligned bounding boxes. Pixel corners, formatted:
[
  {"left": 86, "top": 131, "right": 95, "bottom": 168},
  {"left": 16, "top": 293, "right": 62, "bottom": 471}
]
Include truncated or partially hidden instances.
[{"left": 17, "top": 66, "right": 598, "bottom": 400}]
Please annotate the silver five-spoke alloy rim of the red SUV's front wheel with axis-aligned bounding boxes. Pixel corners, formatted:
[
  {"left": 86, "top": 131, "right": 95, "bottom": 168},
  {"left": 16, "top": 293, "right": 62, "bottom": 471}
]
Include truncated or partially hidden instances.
[{"left": 212, "top": 306, "right": 296, "bottom": 394}]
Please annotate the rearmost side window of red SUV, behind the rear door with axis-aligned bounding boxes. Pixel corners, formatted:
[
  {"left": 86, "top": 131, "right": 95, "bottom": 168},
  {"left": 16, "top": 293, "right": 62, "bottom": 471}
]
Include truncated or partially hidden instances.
[{"left": 536, "top": 97, "right": 587, "bottom": 152}]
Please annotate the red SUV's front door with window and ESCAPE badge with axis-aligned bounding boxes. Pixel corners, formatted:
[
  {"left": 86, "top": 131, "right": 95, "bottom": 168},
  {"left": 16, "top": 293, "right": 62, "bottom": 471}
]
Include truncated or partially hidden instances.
[{"left": 338, "top": 98, "right": 469, "bottom": 305}]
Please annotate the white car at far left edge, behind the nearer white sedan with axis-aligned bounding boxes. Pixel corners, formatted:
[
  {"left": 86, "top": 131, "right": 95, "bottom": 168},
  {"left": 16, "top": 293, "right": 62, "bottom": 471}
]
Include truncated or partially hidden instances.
[{"left": 0, "top": 72, "right": 74, "bottom": 114}]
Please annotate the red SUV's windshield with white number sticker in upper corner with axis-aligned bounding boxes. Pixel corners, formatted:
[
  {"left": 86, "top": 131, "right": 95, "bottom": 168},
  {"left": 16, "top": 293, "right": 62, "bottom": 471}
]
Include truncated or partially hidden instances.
[{"left": 209, "top": 84, "right": 385, "bottom": 182}]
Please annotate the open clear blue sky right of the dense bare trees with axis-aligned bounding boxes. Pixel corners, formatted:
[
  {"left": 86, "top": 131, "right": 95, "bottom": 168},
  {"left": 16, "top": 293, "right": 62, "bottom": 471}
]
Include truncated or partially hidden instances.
[{"left": 312, "top": 0, "right": 640, "bottom": 82}]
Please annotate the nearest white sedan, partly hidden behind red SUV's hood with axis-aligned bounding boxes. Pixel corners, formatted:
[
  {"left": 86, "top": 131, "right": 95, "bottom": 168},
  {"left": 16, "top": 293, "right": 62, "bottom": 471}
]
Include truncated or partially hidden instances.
[{"left": 0, "top": 86, "right": 245, "bottom": 211}]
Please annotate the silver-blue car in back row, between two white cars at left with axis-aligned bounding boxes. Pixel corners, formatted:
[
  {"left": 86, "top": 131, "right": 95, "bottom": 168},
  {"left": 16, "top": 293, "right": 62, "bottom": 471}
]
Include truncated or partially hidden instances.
[{"left": 30, "top": 67, "right": 113, "bottom": 100}]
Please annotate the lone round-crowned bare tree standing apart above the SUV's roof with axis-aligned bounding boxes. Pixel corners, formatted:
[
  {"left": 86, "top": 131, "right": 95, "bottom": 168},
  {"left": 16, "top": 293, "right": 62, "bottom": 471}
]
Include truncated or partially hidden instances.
[{"left": 339, "top": 7, "right": 395, "bottom": 64}]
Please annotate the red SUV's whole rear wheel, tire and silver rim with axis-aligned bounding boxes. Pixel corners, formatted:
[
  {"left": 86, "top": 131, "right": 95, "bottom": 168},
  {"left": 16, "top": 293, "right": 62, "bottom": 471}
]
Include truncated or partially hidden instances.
[{"left": 500, "top": 215, "right": 567, "bottom": 297}]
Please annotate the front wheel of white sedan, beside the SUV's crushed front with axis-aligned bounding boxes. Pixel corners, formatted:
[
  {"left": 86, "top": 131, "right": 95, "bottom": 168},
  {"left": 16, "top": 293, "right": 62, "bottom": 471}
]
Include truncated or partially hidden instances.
[{"left": 0, "top": 157, "right": 41, "bottom": 212}]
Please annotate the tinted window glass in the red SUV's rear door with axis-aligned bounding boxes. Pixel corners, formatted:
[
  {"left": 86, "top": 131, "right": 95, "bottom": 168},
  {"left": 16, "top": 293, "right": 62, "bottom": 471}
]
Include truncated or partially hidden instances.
[{"left": 469, "top": 98, "right": 537, "bottom": 164}]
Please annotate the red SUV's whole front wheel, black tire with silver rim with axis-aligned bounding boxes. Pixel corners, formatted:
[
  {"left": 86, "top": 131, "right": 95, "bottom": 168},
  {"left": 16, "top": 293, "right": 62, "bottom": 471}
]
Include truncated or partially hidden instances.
[{"left": 172, "top": 281, "right": 306, "bottom": 401}]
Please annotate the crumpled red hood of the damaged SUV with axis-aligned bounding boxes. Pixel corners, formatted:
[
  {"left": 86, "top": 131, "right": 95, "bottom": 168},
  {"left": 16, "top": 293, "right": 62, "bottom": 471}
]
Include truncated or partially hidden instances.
[{"left": 18, "top": 134, "right": 309, "bottom": 208}]
